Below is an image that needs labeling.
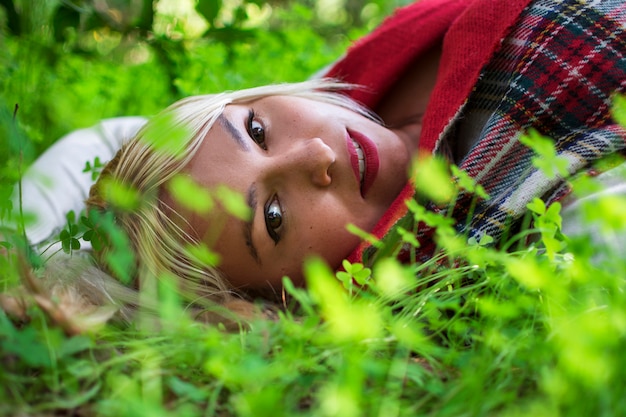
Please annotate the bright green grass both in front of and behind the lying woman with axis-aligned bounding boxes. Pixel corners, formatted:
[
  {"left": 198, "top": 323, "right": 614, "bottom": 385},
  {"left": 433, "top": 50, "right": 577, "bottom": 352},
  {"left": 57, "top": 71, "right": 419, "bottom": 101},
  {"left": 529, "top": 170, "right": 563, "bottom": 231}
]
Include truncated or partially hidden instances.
[{"left": 0, "top": 1, "right": 626, "bottom": 417}]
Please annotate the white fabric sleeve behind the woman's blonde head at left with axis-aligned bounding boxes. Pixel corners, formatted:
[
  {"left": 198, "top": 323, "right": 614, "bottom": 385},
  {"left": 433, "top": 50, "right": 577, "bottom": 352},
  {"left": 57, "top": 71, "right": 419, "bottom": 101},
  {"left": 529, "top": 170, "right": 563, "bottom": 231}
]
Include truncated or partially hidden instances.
[{"left": 13, "top": 117, "right": 147, "bottom": 245}]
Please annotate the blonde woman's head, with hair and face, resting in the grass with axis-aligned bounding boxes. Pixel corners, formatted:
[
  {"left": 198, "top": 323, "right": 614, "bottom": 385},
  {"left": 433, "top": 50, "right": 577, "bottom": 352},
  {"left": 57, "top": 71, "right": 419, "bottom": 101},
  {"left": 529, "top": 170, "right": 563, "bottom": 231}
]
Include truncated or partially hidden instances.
[{"left": 87, "top": 80, "right": 404, "bottom": 316}]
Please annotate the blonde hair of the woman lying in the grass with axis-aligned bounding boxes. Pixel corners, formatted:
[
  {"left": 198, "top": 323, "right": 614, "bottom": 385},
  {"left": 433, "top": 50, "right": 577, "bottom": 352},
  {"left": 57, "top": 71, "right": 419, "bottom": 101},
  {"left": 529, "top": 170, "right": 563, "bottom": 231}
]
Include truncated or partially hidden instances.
[{"left": 87, "top": 79, "right": 375, "bottom": 310}]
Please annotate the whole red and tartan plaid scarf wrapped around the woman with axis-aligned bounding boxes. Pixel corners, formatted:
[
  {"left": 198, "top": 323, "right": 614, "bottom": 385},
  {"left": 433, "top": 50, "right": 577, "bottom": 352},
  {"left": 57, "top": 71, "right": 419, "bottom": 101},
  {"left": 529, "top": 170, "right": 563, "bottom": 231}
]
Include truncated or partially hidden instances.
[{"left": 329, "top": 0, "right": 626, "bottom": 262}]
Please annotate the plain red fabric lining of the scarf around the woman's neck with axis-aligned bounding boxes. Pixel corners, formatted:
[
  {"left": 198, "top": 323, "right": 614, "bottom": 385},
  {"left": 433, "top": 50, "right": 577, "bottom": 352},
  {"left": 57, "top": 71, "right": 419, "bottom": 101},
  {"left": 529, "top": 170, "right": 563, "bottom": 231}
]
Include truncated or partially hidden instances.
[{"left": 326, "top": 0, "right": 530, "bottom": 262}]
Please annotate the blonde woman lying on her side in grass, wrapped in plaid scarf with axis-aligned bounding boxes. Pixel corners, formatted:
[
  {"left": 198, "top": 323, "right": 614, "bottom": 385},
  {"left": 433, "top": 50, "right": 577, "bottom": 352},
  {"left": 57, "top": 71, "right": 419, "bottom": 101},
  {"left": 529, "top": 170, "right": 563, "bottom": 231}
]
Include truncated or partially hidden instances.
[{"left": 2, "top": 0, "right": 626, "bottom": 332}]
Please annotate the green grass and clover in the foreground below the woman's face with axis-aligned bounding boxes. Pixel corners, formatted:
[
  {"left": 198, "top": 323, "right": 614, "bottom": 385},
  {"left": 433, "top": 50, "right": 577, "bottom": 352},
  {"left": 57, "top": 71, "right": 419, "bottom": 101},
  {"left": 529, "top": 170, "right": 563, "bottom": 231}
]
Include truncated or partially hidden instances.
[{"left": 0, "top": 211, "right": 626, "bottom": 416}]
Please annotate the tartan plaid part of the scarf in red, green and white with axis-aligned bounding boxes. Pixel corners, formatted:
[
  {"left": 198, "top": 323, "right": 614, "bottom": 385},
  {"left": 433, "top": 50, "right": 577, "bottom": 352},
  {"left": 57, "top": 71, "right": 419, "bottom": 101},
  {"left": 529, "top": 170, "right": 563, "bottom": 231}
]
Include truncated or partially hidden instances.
[{"left": 363, "top": 0, "right": 626, "bottom": 260}]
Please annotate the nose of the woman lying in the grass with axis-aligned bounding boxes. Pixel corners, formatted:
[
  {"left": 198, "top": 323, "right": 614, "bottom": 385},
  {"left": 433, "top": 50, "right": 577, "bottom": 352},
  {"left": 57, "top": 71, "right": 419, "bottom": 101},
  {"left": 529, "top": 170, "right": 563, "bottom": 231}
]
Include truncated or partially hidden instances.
[{"left": 268, "top": 138, "right": 336, "bottom": 187}]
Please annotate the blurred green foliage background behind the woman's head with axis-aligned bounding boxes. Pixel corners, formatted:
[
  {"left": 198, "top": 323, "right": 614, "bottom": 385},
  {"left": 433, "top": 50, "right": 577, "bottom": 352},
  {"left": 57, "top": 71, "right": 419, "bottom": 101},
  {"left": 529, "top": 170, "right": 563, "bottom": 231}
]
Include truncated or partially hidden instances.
[{"left": 0, "top": 0, "right": 408, "bottom": 166}]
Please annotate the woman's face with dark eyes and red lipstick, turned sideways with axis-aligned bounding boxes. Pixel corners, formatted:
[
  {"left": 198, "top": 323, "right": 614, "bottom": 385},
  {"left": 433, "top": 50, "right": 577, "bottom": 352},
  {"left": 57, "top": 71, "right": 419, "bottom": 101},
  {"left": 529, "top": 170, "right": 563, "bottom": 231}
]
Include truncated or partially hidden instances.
[{"left": 186, "top": 96, "right": 415, "bottom": 288}]
